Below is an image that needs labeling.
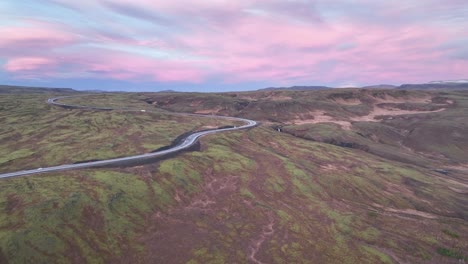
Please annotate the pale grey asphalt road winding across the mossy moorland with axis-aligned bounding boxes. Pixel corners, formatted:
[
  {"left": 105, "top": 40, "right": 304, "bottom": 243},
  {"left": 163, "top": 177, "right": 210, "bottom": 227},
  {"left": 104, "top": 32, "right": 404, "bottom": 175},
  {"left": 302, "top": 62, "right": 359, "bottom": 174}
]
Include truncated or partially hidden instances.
[{"left": 0, "top": 96, "right": 257, "bottom": 178}]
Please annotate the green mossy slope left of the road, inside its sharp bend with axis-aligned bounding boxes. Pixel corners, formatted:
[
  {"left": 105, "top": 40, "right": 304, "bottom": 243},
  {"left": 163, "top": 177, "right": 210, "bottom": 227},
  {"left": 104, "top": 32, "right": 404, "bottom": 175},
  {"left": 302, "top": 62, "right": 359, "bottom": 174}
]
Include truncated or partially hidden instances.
[{"left": 0, "top": 94, "right": 234, "bottom": 172}]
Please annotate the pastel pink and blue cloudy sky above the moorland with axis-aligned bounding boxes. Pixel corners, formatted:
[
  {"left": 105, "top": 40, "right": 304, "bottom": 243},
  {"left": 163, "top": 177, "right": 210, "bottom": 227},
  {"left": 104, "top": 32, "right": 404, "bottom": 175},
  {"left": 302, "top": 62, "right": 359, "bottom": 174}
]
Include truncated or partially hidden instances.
[{"left": 0, "top": 0, "right": 468, "bottom": 92}]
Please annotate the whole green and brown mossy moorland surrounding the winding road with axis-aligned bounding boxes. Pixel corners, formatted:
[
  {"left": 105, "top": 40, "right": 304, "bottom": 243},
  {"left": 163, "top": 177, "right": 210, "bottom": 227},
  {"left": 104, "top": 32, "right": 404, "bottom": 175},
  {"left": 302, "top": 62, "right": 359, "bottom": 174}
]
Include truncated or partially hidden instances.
[{"left": 0, "top": 88, "right": 468, "bottom": 264}]
